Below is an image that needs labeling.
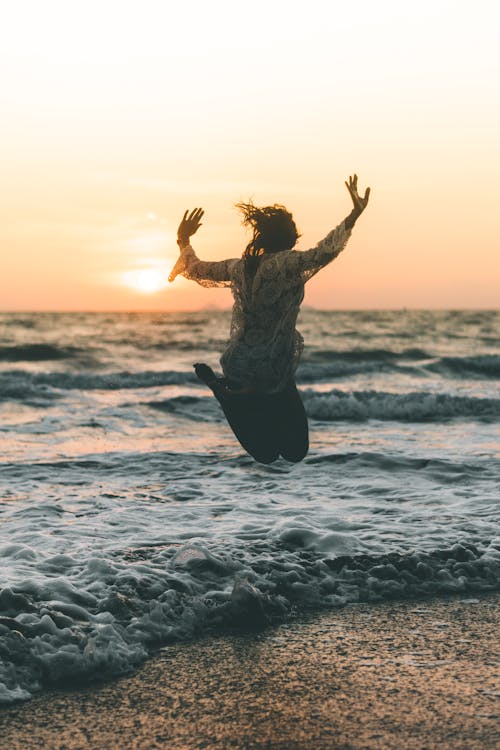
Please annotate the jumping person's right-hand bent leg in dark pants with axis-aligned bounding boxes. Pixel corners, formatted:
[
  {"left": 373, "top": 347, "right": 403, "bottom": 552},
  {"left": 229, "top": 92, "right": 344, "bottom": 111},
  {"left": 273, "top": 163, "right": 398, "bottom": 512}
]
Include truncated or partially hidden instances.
[{"left": 274, "top": 383, "right": 309, "bottom": 463}]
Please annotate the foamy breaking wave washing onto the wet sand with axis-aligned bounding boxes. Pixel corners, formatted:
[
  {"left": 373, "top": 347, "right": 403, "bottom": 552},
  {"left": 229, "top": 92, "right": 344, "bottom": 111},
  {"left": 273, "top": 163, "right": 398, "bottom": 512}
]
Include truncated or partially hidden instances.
[{"left": 0, "top": 527, "right": 500, "bottom": 703}]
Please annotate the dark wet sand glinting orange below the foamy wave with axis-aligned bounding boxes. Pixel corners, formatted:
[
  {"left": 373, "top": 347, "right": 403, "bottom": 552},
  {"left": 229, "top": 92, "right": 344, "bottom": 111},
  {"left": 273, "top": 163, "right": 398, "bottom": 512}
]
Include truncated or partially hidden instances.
[{"left": 0, "top": 595, "right": 500, "bottom": 750}]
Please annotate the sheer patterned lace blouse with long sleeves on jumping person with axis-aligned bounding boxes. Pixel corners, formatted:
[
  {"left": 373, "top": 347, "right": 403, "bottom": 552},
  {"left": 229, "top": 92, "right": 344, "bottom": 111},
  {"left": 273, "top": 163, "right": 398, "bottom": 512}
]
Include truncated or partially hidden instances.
[{"left": 169, "top": 222, "right": 351, "bottom": 393}]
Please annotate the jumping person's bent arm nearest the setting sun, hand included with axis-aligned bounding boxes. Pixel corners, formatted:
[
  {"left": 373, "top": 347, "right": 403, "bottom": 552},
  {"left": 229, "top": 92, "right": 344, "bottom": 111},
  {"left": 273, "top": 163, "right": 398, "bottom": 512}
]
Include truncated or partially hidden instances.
[{"left": 168, "top": 208, "right": 238, "bottom": 286}]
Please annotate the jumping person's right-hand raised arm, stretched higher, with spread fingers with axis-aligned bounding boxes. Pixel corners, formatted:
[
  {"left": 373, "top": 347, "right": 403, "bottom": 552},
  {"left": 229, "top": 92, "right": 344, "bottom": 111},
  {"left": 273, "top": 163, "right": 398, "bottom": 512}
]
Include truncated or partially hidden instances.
[{"left": 291, "top": 175, "right": 370, "bottom": 281}]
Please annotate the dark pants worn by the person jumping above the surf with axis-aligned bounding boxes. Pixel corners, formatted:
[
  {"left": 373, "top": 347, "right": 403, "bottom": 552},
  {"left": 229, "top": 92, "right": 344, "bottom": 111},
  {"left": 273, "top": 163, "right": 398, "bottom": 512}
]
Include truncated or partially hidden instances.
[{"left": 214, "top": 383, "right": 309, "bottom": 464}]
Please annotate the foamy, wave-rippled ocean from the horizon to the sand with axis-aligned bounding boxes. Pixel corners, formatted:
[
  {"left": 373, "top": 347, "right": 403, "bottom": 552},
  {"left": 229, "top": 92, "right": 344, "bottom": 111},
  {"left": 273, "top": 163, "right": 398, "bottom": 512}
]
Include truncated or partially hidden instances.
[{"left": 0, "top": 309, "right": 500, "bottom": 704}]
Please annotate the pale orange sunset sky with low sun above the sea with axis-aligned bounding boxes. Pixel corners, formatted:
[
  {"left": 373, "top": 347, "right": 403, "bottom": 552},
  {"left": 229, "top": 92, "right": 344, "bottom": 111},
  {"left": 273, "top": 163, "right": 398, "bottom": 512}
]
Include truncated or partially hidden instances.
[{"left": 0, "top": 0, "right": 500, "bottom": 310}]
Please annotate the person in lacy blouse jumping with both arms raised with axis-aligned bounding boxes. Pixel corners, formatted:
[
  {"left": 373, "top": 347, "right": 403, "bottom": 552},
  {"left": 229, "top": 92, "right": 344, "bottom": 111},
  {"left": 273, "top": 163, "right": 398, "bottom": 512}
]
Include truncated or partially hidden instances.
[{"left": 169, "top": 175, "right": 370, "bottom": 463}]
